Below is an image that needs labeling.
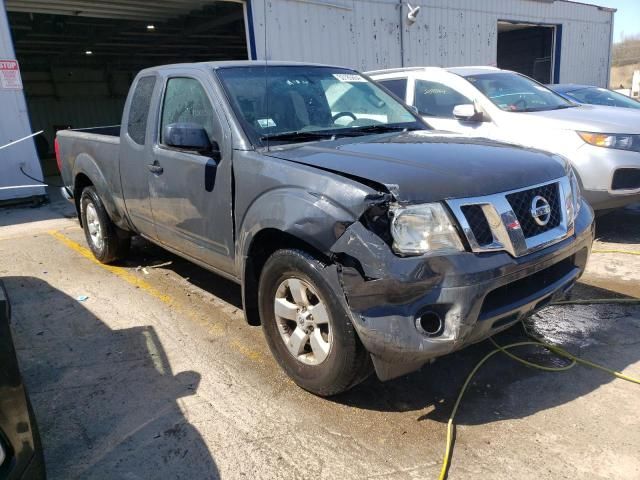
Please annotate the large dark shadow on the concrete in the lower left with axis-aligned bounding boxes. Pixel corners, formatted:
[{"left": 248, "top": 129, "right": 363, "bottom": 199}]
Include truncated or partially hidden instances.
[{"left": 3, "top": 277, "right": 219, "bottom": 480}]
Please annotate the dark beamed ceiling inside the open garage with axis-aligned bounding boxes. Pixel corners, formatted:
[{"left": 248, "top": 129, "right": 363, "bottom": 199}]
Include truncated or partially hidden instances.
[{"left": 7, "top": 0, "right": 247, "bottom": 71}]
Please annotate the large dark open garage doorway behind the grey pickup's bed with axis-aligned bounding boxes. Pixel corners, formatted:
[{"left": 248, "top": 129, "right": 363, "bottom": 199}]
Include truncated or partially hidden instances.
[{"left": 5, "top": 0, "right": 250, "bottom": 176}]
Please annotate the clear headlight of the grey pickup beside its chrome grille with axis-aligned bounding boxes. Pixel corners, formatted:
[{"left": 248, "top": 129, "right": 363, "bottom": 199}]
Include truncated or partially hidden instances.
[{"left": 390, "top": 203, "right": 464, "bottom": 255}]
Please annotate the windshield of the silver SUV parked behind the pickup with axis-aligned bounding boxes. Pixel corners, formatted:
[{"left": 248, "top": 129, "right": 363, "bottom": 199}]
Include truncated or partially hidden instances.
[{"left": 465, "top": 72, "right": 574, "bottom": 112}]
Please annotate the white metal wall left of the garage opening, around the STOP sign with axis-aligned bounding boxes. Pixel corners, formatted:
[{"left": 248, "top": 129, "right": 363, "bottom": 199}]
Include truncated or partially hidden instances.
[{"left": 0, "top": 0, "right": 46, "bottom": 201}]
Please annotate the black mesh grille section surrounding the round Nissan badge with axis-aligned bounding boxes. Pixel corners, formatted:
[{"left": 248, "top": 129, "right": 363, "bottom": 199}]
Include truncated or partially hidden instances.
[{"left": 507, "top": 183, "right": 562, "bottom": 238}]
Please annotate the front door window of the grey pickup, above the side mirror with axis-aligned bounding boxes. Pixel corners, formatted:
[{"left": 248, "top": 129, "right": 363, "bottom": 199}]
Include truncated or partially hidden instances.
[{"left": 160, "top": 78, "right": 215, "bottom": 143}]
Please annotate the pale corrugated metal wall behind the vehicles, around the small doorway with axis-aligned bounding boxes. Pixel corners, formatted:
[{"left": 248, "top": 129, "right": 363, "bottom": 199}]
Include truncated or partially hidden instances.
[{"left": 252, "top": 0, "right": 613, "bottom": 86}]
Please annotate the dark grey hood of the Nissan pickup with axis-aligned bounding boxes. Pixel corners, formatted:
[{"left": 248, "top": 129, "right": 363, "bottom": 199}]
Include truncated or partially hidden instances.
[{"left": 269, "top": 131, "right": 565, "bottom": 203}]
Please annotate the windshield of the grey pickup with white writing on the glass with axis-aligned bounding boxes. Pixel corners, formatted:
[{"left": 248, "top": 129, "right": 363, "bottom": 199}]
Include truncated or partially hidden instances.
[{"left": 217, "top": 65, "right": 427, "bottom": 145}]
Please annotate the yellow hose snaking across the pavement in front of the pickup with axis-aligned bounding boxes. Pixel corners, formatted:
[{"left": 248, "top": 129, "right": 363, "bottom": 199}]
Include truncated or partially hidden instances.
[{"left": 438, "top": 318, "right": 640, "bottom": 480}]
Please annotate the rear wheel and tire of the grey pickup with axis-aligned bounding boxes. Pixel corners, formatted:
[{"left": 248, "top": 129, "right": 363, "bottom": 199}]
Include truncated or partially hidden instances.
[{"left": 80, "top": 187, "right": 131, "bottom": 263}]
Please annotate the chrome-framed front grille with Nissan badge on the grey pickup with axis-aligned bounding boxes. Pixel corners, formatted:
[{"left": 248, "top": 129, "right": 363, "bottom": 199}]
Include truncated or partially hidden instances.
[{"left": 447, "top": 177, "right": 573, "bottom": 257}]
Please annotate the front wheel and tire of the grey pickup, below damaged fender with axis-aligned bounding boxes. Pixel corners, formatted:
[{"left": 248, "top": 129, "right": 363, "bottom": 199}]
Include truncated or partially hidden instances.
[{"left": 258, "top": 249, "right": 372, "bottom": 397}]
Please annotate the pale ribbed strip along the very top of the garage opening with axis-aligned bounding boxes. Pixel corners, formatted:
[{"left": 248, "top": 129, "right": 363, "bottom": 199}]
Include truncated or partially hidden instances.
[{"left": 4, "top": 0, "right": 222, "bottom": 21}]
